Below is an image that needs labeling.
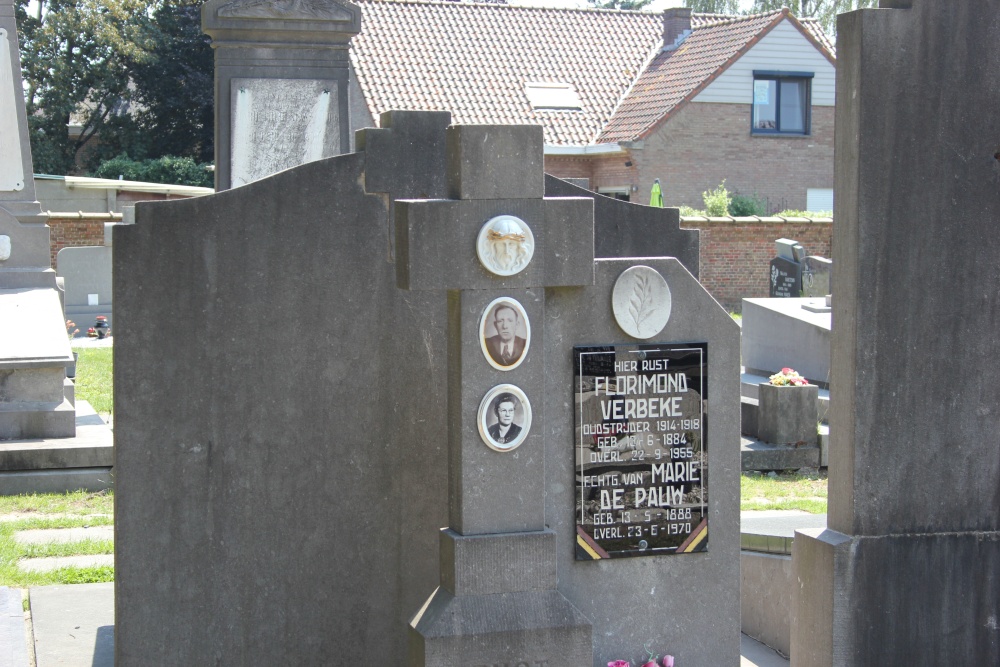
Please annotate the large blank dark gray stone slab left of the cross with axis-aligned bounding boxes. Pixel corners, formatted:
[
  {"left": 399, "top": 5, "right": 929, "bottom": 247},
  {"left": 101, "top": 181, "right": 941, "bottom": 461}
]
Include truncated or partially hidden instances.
[{"left": 113, "top": 117, "right": 448, "bottom": 665}]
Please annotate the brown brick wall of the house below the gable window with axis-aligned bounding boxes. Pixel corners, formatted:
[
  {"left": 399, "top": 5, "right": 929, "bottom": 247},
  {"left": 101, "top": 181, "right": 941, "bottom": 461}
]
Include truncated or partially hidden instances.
[{"left": 631, "top": 103, "right": 833, "bottom": 213}]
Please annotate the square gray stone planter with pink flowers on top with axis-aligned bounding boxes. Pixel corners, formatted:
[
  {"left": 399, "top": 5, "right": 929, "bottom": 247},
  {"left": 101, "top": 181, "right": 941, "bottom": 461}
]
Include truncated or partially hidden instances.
[{"left": 757, "top": 369, "right": 819, "bottom": 445}]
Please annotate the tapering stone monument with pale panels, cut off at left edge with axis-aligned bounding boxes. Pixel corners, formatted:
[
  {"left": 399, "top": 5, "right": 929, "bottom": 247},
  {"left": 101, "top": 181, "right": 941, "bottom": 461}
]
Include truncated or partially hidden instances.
[{"left": 0, "top": 0, "right": 76, "bottom": 438}]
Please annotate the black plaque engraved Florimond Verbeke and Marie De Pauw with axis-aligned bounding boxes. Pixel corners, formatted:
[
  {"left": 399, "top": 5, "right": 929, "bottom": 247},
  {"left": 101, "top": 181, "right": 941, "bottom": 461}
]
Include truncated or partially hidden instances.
[{"left": 573, "top": 343, "right": 708, "bottom": 560}]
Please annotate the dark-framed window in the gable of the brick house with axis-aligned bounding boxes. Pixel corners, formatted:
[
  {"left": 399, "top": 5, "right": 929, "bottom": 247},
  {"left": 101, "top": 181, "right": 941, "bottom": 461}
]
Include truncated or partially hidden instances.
[{"left": 750, "top": 71, "right": 813, "bottom": 135}]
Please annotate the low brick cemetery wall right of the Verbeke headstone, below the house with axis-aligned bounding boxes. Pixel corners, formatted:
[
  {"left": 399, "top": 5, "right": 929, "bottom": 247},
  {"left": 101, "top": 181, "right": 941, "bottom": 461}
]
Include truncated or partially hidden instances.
[{"left": 681, "top": 218, "right": 833, "bottom": 311}]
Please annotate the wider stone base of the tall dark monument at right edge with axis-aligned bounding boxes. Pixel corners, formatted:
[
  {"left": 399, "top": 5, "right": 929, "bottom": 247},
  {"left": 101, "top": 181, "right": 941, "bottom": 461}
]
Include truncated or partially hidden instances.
[{"left": 791, "top": 528, "right": 1000, "bottom": 667}]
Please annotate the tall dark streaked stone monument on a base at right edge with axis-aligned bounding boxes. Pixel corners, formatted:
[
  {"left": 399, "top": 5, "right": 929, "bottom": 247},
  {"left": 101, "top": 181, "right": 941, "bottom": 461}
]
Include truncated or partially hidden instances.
[{"left": 791, "top": 0, "right": 1000, "bottom": 667}]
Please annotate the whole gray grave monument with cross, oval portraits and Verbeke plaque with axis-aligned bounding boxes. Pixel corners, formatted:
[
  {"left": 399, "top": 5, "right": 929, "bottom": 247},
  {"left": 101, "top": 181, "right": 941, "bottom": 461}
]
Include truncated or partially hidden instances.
[{"left": 119, "top": 112, "right": 739, "bottom": 667}]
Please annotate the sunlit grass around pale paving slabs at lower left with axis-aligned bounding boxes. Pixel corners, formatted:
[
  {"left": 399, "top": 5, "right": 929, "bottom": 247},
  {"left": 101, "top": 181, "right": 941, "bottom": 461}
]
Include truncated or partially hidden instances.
[{"left": 0, "top": 491, "right": 115, "bottom": 588}]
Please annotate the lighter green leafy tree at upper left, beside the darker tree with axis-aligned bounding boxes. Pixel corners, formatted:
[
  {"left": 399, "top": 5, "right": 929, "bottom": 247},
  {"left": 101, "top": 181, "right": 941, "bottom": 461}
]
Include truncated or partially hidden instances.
[{"left": 16, "top": 0, "right": 151, "bottom": 174}]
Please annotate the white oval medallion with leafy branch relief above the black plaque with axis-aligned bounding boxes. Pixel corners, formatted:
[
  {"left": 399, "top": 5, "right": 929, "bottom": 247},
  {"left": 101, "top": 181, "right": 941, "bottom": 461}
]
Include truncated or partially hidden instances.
[{"left": 611, "top": 266, "right": 670, "bottom": 340}]
